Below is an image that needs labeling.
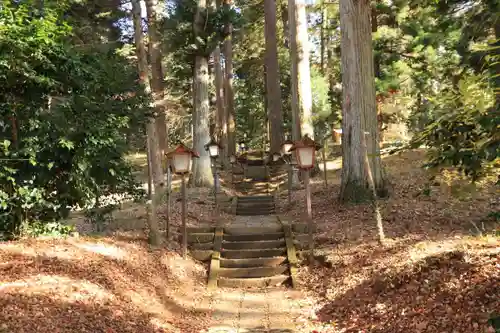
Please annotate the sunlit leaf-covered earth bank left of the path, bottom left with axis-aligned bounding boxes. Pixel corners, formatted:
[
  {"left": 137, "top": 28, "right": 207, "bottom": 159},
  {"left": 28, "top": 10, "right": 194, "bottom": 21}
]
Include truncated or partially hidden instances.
[{"left": 0, "top": 237, "right": 209, "bottom": 333}]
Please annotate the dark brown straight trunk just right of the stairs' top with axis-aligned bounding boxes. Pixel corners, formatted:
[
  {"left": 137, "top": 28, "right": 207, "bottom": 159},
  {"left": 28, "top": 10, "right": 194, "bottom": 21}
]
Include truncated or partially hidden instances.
[{"left": 264, "top": 0, "right": 283, "bottom": 152}]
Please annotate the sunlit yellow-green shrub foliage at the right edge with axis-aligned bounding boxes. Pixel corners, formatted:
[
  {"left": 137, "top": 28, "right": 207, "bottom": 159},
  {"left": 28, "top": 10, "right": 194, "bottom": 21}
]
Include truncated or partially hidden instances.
[{"left": 413, "top": 75, "right": 500, "bottom": 180}]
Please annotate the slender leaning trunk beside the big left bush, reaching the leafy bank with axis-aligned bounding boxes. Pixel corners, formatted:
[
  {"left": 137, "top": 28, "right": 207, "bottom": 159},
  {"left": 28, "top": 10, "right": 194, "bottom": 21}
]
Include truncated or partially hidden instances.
[{"left": 132, "top": 0, "right": 162, "bottom": 246}]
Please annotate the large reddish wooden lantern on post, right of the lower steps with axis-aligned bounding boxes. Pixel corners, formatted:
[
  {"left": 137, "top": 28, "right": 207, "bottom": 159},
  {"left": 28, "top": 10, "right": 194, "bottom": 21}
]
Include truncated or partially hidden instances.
[{"left": 290, "top": 134, "right": 321, "bottom": 262}]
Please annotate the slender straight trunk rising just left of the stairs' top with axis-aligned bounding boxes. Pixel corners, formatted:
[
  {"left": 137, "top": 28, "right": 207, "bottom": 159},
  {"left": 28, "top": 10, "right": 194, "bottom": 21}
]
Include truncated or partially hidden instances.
[{"left": 223, "top": 0, "right": 236, "bottom": 156}]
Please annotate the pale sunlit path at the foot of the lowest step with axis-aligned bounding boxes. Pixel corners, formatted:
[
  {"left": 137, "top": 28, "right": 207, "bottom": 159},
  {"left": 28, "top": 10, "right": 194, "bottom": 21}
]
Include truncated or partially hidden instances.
[{"left": 204, "top": 288, "right": 308, "bottom": 333}]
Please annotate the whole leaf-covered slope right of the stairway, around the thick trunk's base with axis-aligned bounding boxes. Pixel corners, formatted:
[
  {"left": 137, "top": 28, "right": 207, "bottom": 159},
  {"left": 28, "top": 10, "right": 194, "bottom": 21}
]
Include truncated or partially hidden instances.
[{"left": 282, "top": 150, "right": 500, "bottom": 333}]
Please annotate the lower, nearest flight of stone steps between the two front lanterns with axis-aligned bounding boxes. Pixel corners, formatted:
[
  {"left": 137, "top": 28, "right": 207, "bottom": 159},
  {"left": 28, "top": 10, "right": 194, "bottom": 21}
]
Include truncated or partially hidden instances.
[{"left": 188, "top": 216, "right": 307, "bottom": 288}]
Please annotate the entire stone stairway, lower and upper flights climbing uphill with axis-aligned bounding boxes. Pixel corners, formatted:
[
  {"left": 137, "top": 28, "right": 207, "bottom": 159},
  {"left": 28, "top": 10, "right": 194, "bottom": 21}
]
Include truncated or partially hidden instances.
[{"left": 184, "top": 159, "right": 307, "bottom": 288}]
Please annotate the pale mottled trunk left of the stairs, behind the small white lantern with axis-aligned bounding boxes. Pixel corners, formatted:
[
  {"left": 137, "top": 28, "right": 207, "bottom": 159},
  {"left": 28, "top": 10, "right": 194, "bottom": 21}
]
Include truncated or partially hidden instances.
[{"left": 190, "top": 0, "right": 213, "bottom": 187}]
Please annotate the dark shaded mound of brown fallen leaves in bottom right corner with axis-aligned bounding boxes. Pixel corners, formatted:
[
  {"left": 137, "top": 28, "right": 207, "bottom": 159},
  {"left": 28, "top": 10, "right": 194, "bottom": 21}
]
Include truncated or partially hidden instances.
[{"left": 318, "top": 251, "right": 500, "bottom": 333}]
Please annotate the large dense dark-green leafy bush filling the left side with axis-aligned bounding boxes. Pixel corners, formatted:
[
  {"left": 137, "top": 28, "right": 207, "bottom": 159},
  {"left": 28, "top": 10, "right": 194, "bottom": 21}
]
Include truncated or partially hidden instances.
[{"left": 0, "top": 4, "right": 150, "bottom": 234}]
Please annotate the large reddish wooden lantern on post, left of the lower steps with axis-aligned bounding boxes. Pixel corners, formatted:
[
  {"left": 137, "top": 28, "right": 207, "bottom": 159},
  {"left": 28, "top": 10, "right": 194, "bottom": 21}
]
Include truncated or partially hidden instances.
[{"left": 167, "top": 143, "right": 200, "bottom": 259}]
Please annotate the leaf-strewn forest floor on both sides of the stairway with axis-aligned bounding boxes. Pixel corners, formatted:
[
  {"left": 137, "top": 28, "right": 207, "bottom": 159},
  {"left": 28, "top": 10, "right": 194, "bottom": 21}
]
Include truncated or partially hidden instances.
[{"left": 0, "top": 150, "right": 500, "bottom": 333}]
